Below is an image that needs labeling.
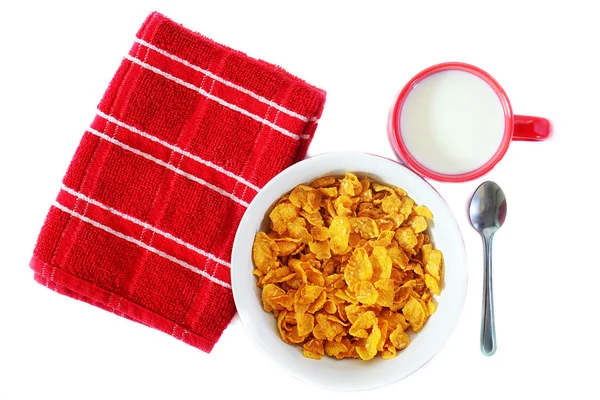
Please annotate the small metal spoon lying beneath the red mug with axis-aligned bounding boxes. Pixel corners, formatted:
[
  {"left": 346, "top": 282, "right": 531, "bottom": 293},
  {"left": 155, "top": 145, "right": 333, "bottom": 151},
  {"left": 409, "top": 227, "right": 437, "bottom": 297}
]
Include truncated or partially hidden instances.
[{"left": 469, "top": 181, "right": 506, "bottom": 356}]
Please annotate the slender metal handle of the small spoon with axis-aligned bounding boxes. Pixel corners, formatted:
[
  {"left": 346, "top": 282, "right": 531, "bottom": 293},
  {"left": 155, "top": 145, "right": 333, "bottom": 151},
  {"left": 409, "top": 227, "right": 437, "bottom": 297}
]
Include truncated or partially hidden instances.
[{"left": 481, "top": 235, "right": 496, "bottom": 356}]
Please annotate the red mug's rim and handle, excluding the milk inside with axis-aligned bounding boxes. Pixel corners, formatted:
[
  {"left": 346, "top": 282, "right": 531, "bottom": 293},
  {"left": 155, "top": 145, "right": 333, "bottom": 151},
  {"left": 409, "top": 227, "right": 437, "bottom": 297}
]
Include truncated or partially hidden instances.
[{"left": 388, "top": 62, "right": 550, "bottom": 182}]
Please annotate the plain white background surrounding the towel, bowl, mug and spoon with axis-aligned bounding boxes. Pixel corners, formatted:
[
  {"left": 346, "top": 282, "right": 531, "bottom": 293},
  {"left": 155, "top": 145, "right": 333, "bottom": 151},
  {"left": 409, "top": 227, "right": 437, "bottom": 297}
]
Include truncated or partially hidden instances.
[{"left": 0, "top": 0, "right": 600, "bottom": 399}]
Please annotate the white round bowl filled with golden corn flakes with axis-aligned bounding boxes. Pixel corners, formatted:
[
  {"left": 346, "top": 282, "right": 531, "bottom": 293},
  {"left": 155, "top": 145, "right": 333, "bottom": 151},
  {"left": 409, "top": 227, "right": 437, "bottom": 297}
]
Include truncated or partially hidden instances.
[{"left": 231, "top": 152, "right": 467, "bottom": 390}]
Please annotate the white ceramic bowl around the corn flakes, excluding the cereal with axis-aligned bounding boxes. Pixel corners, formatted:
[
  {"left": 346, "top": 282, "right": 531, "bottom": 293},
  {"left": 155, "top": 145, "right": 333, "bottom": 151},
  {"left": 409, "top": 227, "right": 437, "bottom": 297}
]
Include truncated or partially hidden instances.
[{"left": 231, "top": 152, "right": 467, "bottom": 390}]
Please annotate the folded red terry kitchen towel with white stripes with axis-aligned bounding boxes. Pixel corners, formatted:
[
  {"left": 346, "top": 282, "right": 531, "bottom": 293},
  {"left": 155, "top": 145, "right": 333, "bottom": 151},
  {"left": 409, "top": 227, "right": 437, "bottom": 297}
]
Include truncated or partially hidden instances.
[{"left": 31, "top": 13, "right": 325, "bottom": 352}]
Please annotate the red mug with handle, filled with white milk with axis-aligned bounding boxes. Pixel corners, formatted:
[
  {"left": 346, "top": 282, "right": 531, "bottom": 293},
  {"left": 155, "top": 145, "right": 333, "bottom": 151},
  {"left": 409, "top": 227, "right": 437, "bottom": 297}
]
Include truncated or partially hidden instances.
[{"left": 388, "top": 62, "right": 550, "bottom": 182}]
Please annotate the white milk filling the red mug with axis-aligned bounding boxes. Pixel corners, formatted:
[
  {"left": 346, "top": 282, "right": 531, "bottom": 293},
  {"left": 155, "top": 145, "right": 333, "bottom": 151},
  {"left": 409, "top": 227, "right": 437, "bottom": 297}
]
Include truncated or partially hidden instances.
[{"left": 400, "top": 70, "right": 504, "bottom": 175}]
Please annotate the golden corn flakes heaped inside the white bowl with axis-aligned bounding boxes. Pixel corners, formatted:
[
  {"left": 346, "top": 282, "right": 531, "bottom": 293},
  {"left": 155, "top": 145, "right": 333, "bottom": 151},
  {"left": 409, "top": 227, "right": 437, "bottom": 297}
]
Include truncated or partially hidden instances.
[{"left": 252, "top": 173, "right": 443, "bottom": 360}]
